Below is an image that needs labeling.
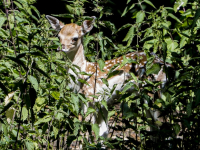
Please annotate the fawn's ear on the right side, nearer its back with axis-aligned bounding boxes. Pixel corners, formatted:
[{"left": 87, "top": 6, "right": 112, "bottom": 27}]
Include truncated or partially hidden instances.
[{"left": 82, "top": 16, "right": 96, "bottom": 35}]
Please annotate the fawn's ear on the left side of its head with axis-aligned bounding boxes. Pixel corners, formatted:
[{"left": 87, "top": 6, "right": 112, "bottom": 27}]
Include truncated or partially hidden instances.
[{"left": 46, "top": 15, "right": 64, "bottom": 31}]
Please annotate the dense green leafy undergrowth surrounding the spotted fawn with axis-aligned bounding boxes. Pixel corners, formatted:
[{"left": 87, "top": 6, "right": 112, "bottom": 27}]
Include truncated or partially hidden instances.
[{"left": 0, "top": 0, "right": 200, "bottom": 150}]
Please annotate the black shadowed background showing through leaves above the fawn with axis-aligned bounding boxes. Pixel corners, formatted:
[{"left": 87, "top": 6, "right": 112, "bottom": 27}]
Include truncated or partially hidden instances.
[{"left": 35, "top": 0, "right": 175, "bottom": 52}]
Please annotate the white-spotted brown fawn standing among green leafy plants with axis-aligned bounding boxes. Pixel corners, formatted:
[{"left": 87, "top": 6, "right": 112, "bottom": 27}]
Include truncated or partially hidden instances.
[{"left": 46, "top": 15, "right": 173, "bottom": 145}]
